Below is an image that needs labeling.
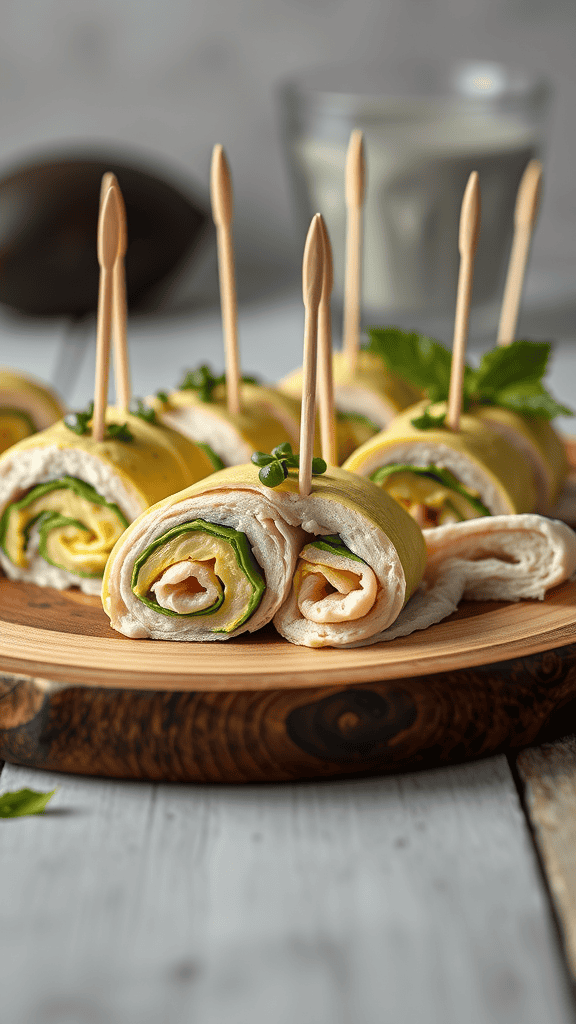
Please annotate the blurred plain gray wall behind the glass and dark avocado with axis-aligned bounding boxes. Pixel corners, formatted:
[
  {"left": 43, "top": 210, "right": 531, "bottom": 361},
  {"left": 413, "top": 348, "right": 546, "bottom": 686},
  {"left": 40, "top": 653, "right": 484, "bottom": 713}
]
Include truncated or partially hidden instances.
[{"left": 0, "top": 0, "right": 576, "bottom": 291}]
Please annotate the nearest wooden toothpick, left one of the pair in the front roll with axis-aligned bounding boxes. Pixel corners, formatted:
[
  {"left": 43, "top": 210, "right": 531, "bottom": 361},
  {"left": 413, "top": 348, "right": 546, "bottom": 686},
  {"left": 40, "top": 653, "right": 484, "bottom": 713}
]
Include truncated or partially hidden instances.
[{"left": 298, "top": 213, "right": 324, "bottom": 498}]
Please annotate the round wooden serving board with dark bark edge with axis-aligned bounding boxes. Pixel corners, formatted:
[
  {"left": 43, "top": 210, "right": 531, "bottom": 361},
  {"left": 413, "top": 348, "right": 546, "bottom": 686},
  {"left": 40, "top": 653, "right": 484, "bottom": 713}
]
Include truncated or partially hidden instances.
[{"left": 0, "top": 579, "right": 576, "bottom": 782}]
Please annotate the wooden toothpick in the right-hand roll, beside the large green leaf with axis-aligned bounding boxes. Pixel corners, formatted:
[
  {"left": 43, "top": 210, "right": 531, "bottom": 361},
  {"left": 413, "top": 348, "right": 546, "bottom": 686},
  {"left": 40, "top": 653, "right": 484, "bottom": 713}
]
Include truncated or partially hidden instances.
[{"left": 446, "top": 171, "right": 480, "bottom": 431}]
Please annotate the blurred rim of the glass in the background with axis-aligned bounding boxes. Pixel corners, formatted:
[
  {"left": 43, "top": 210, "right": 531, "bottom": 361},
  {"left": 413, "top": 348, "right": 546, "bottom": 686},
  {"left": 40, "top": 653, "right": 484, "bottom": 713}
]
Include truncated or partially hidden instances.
[{"left": 279, "top": 59, "right": 553, "bottom": 120}]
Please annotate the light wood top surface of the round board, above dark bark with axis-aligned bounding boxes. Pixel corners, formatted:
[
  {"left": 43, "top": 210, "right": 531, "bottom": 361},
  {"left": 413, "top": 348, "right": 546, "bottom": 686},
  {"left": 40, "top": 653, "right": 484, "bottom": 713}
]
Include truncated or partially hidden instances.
[{"left": 0, "top": 583, "right": 576, "bottom": 691}]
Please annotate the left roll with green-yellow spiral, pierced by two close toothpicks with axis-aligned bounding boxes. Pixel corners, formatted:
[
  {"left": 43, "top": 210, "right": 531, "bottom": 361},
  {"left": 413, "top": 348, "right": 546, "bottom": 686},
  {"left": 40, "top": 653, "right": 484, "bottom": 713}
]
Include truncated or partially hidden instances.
[{"left": 0, "top": 409, "right": 213, "bottom": 594}]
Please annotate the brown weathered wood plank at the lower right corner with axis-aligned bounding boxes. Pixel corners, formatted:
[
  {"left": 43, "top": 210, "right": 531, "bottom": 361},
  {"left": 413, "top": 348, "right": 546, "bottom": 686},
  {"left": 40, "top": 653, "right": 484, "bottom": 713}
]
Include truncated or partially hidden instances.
[{"left": 517, "top": 736, "right": 576, "bottom": 981}]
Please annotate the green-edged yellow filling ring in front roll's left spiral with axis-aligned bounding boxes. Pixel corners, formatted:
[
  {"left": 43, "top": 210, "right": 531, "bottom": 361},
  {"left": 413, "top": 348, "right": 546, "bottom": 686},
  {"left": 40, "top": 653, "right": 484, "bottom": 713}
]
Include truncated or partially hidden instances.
[{"left": 131, "top": 519, "right": 265, "bottom": 633}]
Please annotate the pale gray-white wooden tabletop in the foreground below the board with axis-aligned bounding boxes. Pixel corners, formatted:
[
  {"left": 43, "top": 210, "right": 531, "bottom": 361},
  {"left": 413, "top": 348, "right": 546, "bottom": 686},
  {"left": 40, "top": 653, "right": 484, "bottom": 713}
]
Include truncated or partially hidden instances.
[{"left": 0, "top": 758, "right": 574, "bottom": 1024}]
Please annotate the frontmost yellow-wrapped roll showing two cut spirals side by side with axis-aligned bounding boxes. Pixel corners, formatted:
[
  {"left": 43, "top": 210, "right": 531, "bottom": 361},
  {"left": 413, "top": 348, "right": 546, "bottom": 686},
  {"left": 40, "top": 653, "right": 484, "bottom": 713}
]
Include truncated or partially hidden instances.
[{"left": 102, "top": 464, "right": 425, "bottom": 646}]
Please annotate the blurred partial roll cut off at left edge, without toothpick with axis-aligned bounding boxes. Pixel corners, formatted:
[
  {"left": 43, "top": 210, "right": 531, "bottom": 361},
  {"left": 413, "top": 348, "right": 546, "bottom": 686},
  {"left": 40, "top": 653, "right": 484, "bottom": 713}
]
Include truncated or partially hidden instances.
[{"left": 0, "top": 369, "right": 65, "bottom": 453}]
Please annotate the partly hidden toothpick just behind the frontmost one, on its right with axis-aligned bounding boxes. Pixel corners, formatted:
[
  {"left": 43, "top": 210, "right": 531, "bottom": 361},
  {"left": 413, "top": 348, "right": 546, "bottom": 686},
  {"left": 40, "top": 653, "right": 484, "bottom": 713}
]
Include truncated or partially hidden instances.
[{"left": 318, "top": 214, "right": 338, "bottom": 466}]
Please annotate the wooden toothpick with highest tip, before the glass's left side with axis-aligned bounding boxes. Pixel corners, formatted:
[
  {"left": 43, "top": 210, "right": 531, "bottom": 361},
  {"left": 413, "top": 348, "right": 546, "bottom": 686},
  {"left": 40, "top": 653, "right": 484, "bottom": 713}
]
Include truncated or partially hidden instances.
[{"left": 343, "top": 128, "right": 366, "bottom": 373}]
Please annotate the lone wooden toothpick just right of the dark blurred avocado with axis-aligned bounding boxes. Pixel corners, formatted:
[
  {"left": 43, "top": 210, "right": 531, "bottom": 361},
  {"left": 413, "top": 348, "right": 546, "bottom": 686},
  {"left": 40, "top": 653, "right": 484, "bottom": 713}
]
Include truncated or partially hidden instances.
[{"left": 210, "top": 145, "right": 240, "bottom": 416}]
